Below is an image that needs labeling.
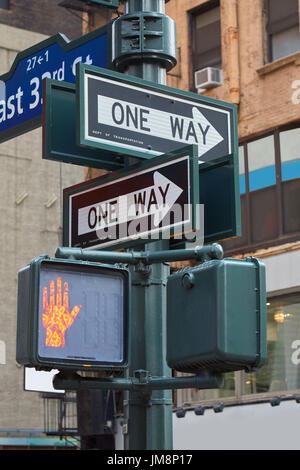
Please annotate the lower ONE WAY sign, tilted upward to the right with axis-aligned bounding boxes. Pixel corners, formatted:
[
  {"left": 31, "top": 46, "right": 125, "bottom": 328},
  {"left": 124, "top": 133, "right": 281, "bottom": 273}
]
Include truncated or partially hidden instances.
[{"left": 63, "top": 145, "right": 199, "bottom": 252}]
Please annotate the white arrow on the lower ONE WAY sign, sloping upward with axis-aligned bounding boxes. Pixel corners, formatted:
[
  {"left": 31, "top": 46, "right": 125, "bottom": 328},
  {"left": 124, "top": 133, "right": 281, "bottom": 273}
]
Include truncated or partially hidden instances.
[{"left": 78, "top": 171, "right": 183, "bottom": 235}]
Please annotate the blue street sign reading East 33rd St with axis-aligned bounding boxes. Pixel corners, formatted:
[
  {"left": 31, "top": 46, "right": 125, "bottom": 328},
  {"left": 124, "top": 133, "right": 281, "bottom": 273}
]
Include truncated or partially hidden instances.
[{"left": 0, "top": 26, "right": 108, "bottom": 142}]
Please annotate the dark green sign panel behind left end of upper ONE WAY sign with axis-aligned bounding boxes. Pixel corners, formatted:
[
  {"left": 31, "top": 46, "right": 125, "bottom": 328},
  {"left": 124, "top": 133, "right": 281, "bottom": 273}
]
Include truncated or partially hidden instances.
[{"left": 43, "top": 78, "right": 124, "bottom": 171}]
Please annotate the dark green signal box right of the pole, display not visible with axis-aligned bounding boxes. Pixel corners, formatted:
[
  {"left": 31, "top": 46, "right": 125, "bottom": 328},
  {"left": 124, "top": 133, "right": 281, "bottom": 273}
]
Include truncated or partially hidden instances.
[{"left": 167, "top": 258, "right": 266, "bottom": 373}]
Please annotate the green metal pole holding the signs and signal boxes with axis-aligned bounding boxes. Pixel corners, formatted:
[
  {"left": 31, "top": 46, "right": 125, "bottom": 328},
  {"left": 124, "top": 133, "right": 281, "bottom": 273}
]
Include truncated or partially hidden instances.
[{"left": 120, "top": 0, "right": 173, "bottom": 450}]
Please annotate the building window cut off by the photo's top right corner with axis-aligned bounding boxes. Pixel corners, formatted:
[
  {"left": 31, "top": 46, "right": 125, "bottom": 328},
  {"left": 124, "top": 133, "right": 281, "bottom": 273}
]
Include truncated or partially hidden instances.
[{"left": 266, "top": 0, "right": 300, "bottom": 62}]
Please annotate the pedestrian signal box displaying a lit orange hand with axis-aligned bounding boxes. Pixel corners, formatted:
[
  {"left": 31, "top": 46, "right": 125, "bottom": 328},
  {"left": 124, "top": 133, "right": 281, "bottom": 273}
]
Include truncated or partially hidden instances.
[{"left": 17, "top": 256, "right": 129, "bottom": 373}]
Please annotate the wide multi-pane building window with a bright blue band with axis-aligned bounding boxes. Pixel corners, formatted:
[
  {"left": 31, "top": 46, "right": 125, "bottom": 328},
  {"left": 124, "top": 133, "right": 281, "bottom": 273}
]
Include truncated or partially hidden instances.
[{"left": 222, "top": 124, "right": 300, "bottom": 256}]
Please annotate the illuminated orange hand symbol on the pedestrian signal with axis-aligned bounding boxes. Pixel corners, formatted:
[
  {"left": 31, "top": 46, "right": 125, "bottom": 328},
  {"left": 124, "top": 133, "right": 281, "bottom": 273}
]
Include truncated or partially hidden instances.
[{"left": 42, "top": 277, "right": 81, "bottom": 348}]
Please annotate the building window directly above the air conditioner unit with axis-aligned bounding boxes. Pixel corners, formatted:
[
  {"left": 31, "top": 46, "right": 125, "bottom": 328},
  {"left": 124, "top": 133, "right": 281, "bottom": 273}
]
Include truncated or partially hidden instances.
[{"left": 192, "top": 2, "right": 222, "bottom": 72}]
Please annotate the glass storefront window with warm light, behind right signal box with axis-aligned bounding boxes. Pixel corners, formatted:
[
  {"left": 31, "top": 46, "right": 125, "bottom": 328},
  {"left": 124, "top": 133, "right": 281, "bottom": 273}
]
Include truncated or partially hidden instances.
[{"left": 178, "top": 293, "right": 300, "bottom": 406}]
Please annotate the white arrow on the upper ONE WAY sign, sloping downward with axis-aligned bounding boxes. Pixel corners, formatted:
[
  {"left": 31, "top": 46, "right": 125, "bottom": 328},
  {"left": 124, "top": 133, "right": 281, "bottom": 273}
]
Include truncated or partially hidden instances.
[{"left": 98, "top": 95, "right": 224, "bottom": 157}]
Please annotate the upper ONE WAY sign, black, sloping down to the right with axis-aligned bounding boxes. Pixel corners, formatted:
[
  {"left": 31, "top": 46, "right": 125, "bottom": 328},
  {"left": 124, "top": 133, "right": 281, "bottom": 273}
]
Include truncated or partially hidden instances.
[{"left": 78, "top": 64, "right": 236, "bottom": 162}]
